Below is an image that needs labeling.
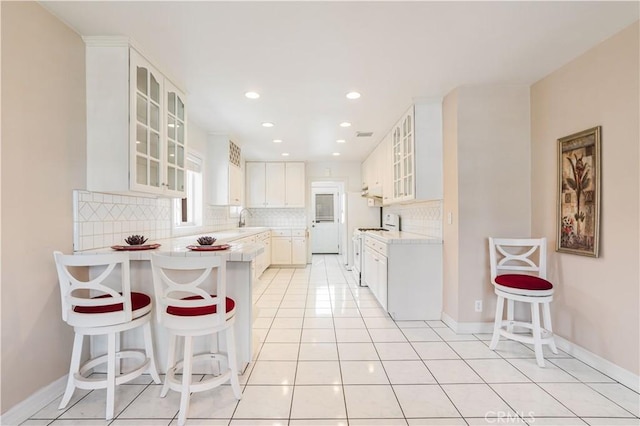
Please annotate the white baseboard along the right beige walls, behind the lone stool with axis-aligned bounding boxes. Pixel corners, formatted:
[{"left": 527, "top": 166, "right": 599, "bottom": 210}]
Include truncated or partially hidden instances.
[{"left": 442, "top": 312, "right": 640, "bottom": 392}]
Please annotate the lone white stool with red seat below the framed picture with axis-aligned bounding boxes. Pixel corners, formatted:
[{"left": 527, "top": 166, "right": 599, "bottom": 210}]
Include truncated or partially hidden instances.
[{"left": 489, "top": 238, "right": 558, "bottom": 367}]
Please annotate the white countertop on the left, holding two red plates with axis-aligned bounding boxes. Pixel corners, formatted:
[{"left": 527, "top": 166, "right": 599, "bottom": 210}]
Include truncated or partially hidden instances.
[{"left": 76, "top": 226, "right": 284, "bottom": 262}]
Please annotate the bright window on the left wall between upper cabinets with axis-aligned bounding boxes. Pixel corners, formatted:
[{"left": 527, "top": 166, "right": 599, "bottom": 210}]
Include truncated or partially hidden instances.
[{"left": 173, "top": 153, "right": 203, "bottom": 227}]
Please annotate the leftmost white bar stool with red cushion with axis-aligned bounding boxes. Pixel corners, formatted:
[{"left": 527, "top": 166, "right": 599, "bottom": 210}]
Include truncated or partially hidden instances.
[{"left": 53, "top": 251, "right": 160, "bottom": 420}]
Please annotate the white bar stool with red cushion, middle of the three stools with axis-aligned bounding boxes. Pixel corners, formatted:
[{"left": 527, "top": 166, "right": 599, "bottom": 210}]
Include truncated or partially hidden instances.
[{"left": 151, "top": 253, "right": 242, "bottom": 426}]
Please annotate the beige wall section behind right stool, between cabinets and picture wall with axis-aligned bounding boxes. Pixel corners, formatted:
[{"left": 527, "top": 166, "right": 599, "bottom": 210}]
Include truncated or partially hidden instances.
[{"left": 443, "top": 85, "right": 531, "bottom": 322}]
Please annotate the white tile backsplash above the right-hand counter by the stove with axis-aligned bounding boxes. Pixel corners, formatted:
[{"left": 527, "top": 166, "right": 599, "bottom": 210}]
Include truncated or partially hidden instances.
[{"left": 384, "top": 200, "right": 442, "bottom": 238}]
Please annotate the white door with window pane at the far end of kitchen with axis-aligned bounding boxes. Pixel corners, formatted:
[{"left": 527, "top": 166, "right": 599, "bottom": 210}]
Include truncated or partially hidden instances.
[{"left": 311, "top": 188, "right": 340, "bottom": 254}]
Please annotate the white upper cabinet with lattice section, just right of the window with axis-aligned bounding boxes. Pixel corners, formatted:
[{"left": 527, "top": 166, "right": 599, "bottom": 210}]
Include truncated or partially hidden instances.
[{"left": 206, "top": 134, "right": 244, "bottom": 206}]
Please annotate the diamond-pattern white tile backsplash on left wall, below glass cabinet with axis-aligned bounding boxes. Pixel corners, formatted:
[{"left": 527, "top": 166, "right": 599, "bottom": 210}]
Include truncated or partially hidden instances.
[{"left": 73, "top": 190, "right": 237, "bottom": 251}]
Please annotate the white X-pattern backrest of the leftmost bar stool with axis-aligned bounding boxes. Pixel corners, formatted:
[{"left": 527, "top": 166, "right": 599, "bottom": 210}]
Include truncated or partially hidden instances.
[{"left": 53, "top": 251, "right": 133, "bottom": 327}]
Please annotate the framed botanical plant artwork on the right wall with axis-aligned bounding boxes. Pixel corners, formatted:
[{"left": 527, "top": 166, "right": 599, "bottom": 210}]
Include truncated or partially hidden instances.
[{"left": 556, "top": 126, "right": 602, "bottom": 257}]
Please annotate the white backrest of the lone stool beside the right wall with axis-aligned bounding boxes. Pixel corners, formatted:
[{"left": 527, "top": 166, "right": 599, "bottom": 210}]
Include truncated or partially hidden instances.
[{"left": 489, "top": 237, "right": 547, "bottom": 284}]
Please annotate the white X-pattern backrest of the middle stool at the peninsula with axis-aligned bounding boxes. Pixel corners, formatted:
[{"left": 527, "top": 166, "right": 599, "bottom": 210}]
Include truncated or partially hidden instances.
[{"left": 151, "top": 254, "right": 227, "bottom": 327}]
